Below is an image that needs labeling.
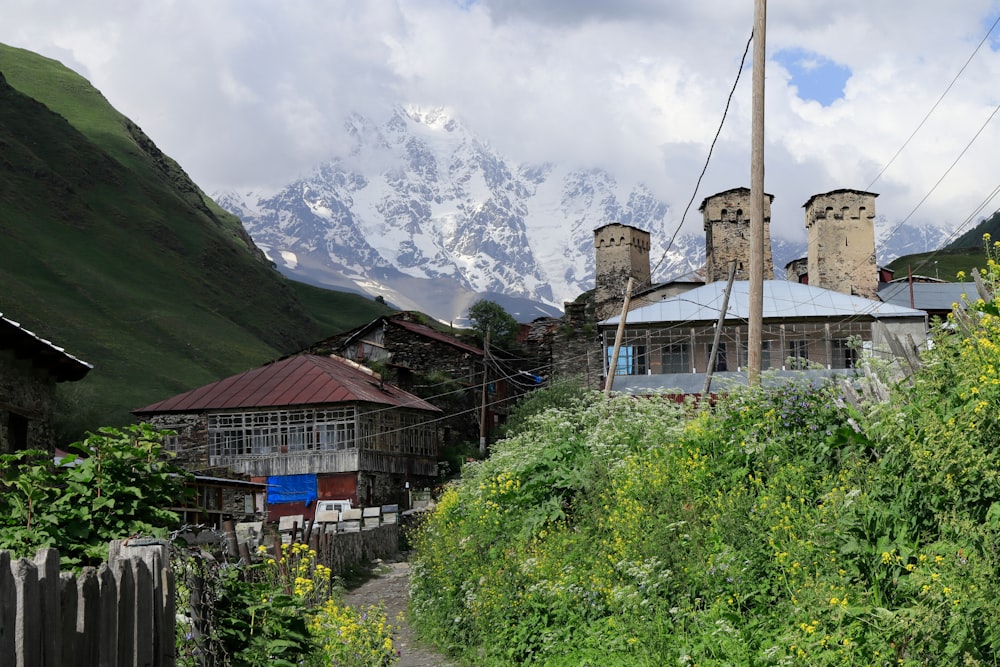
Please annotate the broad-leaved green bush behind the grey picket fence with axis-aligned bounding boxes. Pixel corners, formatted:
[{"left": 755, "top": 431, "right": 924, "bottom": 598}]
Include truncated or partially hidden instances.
[{"left": 0, "top": 424, "right": 188, "bottom": 567}]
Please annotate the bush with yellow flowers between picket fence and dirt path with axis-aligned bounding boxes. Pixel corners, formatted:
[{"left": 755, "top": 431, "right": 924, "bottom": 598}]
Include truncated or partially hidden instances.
[{"left": 174, "top": 543, "right": 396, "bottom": 667}]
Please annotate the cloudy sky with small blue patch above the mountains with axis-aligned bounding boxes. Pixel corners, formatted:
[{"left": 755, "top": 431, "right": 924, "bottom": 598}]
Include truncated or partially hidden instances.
[{"left": 0, "top": 0, "right": 1000, "bottom": 244}]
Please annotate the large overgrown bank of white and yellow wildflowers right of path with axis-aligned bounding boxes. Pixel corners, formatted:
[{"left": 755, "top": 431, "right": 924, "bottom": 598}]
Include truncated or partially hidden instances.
[{"left": 411, "top": 254, "right": 1000, "bottom": 666}]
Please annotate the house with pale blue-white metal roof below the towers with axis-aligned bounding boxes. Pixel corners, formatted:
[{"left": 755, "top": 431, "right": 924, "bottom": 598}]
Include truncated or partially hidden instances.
[{"left": 599, "top": 280, "right": 927, "bottom": 394}]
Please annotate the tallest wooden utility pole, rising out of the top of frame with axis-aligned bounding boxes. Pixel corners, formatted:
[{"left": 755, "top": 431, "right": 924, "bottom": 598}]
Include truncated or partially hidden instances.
[{"left": 747, "top": 0, "right": 767, "bottom": 386}]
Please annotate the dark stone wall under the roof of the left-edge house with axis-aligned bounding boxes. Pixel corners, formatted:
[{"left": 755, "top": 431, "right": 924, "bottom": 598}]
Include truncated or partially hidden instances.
[{"left": 0, "top": 354, "right": 56, "bottom": 454}]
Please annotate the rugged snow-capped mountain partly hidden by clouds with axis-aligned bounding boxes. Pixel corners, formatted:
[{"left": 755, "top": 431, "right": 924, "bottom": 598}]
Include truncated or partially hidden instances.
[{"left": 215, "top": 107, "right": 944, "bottom": 322}]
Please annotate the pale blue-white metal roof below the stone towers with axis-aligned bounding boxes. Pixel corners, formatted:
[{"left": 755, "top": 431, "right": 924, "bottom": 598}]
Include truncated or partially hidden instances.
[{"left": 601, "top": 280, "right": 925, "bottom": 325}]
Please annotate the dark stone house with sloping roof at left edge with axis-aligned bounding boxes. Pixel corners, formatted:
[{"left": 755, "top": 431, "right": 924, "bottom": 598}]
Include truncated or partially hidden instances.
[{"left": 0, "top": 314, "right": 92, "bottom": 454}]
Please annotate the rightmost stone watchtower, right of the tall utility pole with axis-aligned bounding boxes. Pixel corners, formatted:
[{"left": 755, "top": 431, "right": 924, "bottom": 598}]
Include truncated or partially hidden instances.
[{"left": 805, "top": 190, "right": 878, "bottom": 299}]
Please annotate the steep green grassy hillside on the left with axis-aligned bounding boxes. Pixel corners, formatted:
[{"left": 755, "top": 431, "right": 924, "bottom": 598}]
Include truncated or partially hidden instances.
[{"left": 0, "top": 45, "right": 388, "bottom": 438}]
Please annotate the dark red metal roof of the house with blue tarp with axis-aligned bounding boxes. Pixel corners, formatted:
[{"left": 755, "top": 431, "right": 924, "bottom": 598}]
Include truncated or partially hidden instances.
[{"left": 132, "top": 354, "right": 440, "bottom": 415}]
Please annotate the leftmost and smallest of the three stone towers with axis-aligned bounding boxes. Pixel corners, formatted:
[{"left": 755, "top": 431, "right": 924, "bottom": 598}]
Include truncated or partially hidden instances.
[{"left": 594, "top": 223, "right": 649, "bottom": 320}]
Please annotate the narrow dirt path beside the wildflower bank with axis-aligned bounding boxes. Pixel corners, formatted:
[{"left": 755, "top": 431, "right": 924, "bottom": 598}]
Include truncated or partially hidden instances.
[{"left": 344, "top": 557, "right": 457, "bottom": 667}]
